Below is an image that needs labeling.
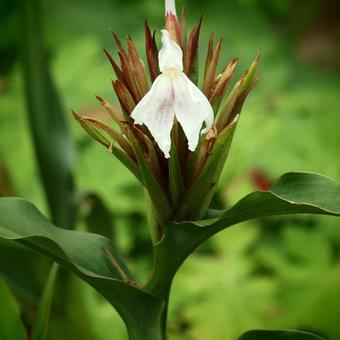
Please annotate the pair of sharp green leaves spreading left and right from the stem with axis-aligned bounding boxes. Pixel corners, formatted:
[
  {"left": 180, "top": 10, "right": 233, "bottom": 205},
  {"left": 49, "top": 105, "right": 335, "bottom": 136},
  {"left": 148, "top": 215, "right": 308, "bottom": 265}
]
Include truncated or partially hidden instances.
[{"left": 0, "top": 173, "right": 340, "bottom": 340}]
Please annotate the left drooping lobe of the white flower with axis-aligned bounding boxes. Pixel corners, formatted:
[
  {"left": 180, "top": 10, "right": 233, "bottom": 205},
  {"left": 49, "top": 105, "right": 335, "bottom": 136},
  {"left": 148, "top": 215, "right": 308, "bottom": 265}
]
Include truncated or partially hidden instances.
[{"left": 131, "top": 75, "right": 175, "bottom": 158}]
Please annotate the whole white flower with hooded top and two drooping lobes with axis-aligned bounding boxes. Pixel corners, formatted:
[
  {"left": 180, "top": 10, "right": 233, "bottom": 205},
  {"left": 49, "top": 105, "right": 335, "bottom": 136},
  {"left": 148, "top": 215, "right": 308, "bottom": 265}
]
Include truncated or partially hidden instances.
[{"left": 131, "top": 30, "right": 214, "bottom": 158}]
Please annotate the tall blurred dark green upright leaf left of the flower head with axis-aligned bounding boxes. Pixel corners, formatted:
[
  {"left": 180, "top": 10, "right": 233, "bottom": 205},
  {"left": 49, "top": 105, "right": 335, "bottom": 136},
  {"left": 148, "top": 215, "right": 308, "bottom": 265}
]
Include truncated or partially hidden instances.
[{"left": 20, "top": 0, "right": 75, "bottom": 227}]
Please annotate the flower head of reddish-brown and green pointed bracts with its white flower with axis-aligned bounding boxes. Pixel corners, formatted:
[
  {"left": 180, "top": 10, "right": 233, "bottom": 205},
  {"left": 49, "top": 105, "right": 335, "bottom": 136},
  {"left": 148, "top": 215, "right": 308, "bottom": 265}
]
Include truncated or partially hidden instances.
[{"left": 74, "top": 0, "right": 259, "bottom": 228}]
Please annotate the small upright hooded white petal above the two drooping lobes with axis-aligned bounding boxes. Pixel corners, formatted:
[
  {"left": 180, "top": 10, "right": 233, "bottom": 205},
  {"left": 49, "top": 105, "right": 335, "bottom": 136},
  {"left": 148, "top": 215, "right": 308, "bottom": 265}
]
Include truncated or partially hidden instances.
[{"left": 158, "top": 30, "right": 183, "bottom": 73}]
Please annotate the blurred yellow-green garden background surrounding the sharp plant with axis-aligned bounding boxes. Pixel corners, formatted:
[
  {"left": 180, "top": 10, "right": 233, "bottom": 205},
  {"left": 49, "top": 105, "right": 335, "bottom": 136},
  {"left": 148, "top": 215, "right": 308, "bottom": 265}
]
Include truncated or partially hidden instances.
[{"left": 0, "top": 0, "right": 340, "bottom": 340}]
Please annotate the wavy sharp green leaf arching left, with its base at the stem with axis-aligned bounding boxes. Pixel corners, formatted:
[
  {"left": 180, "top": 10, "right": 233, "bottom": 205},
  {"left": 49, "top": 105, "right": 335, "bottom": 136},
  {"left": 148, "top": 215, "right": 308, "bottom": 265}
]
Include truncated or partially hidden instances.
[{"left": 0, "top": 198, "right": 164, "bottom": 340}]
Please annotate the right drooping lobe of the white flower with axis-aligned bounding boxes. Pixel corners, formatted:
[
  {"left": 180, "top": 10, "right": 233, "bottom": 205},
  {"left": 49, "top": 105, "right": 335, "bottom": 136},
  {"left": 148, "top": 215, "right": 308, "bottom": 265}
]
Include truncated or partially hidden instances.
[{"left": 173, "top": 73, "right": 214, "bottom": 151}]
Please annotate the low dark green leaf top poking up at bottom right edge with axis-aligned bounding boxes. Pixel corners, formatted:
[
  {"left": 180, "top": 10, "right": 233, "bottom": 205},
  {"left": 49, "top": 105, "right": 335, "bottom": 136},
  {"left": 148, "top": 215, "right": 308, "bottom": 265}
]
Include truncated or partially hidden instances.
[{"left": 238, "top": 330, "right": 324, "bottom": 340}]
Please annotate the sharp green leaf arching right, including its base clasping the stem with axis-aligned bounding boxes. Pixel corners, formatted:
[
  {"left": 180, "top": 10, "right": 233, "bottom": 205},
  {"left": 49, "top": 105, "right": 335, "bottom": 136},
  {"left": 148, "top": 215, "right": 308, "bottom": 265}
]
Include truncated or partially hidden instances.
[{"left": 147, "top": 172, "right": 340, "bottom": 296}]
